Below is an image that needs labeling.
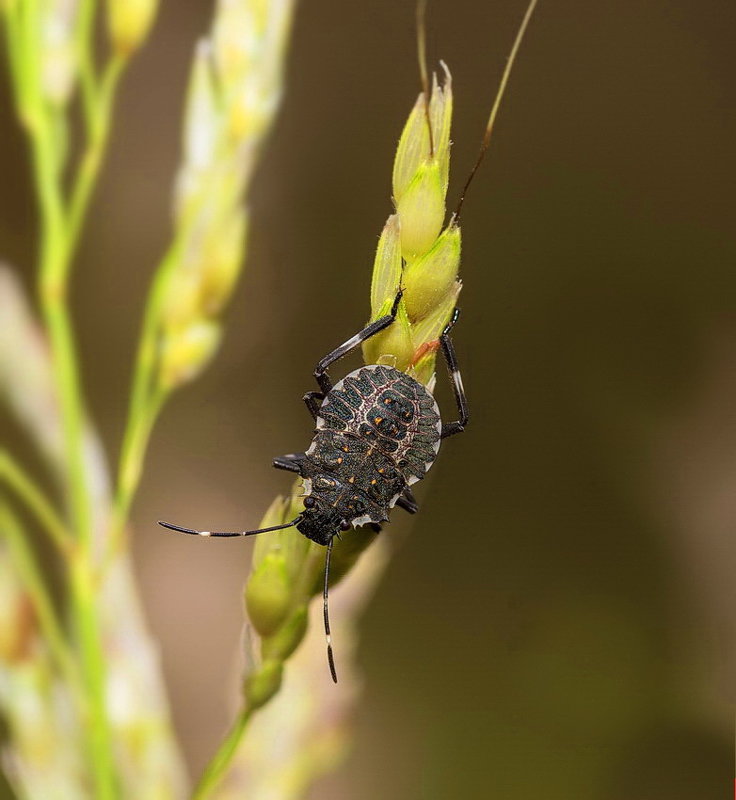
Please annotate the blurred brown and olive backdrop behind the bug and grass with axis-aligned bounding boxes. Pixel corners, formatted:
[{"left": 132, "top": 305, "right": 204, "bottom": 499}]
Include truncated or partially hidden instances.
[{"left": 0, "top": 0, "right": 736, "bottom": 800}]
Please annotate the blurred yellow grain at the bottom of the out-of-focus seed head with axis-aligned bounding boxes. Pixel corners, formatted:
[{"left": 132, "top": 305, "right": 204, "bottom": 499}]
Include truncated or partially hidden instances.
[{"left": 160, "top": 320, "right": 221, "bottom": 389}]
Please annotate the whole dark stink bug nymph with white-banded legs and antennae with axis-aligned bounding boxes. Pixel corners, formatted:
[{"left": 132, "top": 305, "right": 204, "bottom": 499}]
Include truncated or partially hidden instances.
[{"left": 159, "top": 290, "right": 468, "bottom": 682}]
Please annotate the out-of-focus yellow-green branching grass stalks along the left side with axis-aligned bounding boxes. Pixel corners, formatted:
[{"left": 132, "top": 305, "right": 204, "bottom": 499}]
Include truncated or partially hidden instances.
[{"left": 0, "top": 0, "right": 294, "bottom": 800}]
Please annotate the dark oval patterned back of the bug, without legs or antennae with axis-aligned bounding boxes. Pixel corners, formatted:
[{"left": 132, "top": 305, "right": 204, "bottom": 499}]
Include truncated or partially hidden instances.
[{"left": 300, "top": 366, "right": 442, "bottom": 532}]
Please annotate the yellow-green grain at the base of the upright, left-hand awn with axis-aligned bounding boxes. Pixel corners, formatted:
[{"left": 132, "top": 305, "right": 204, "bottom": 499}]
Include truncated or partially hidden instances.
[{"left": 396, "top": 161, "right": 445, "bottom": 264}]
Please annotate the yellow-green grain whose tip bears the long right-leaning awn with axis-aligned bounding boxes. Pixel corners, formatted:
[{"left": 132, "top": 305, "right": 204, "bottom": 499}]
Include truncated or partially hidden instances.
[{"left": 403, "top": 225, "right": 460, "bottom": 322}]
